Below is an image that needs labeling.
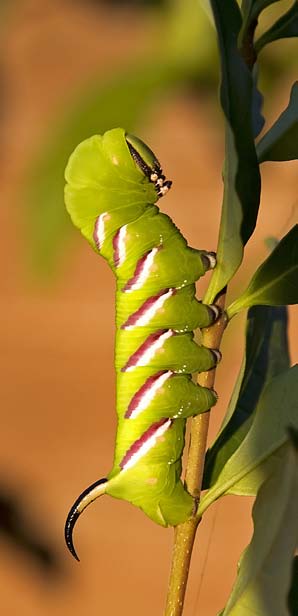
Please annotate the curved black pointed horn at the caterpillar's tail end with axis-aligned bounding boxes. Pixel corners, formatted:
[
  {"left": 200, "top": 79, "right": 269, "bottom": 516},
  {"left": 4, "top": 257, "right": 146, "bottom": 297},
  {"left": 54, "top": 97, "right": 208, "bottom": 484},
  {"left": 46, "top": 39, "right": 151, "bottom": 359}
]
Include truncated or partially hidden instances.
[{"left": 64, "top": 478, "right": 108, "bottom": 561}]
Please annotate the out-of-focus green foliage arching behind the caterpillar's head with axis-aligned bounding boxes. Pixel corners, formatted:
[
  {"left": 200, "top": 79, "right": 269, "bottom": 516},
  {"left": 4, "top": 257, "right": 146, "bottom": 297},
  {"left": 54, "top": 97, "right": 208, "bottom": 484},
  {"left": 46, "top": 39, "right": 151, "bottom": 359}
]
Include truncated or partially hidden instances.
[{"left": 14, "top": 0, "right": 295, "bottom": 279}]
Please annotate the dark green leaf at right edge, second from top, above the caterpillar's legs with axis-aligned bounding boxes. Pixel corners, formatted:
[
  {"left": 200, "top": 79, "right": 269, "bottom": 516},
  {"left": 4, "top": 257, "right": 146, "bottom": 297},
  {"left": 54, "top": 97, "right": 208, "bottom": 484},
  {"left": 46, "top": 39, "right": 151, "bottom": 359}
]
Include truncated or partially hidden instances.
[{"left": 257, "top": 81, "right": 298, "bottom": 163}]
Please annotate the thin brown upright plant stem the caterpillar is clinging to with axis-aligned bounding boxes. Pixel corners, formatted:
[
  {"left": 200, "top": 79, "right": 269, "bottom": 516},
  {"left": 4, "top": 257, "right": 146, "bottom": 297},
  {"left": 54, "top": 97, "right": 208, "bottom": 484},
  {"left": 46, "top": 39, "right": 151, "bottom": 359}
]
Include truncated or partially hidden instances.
[{"left": 165, "top": 289, "right": 226, "bottom": 616}]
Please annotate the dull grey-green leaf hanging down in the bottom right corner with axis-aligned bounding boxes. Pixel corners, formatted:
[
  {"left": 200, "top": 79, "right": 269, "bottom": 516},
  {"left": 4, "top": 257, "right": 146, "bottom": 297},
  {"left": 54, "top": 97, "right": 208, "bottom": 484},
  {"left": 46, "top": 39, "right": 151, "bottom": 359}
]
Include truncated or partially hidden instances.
[{"left": 223, "top": 440, "right": 298, "bottom": 616}]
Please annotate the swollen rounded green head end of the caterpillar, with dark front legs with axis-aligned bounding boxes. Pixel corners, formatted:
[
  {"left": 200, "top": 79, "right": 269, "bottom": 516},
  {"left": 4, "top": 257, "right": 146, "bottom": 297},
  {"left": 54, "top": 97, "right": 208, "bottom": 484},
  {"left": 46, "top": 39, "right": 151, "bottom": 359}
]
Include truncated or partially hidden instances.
[{"left": 65, "top": 128, "right": 172, "bottom": 250}]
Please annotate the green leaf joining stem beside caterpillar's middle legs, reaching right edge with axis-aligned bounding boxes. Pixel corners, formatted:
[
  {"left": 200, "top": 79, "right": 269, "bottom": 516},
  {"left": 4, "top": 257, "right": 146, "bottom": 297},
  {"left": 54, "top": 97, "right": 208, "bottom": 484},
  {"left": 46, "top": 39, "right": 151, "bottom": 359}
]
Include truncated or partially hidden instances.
[{"left": 227, "top": 225, "right": 298, "bottom": 318}]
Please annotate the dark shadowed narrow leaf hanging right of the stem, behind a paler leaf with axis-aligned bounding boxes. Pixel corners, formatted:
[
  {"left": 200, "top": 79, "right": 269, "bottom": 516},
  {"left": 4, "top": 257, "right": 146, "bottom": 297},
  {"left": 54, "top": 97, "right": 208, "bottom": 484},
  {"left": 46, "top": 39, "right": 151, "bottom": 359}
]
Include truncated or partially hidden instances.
[{"left": 203, "top": 306, "right": 290, "bottom": 494}]
